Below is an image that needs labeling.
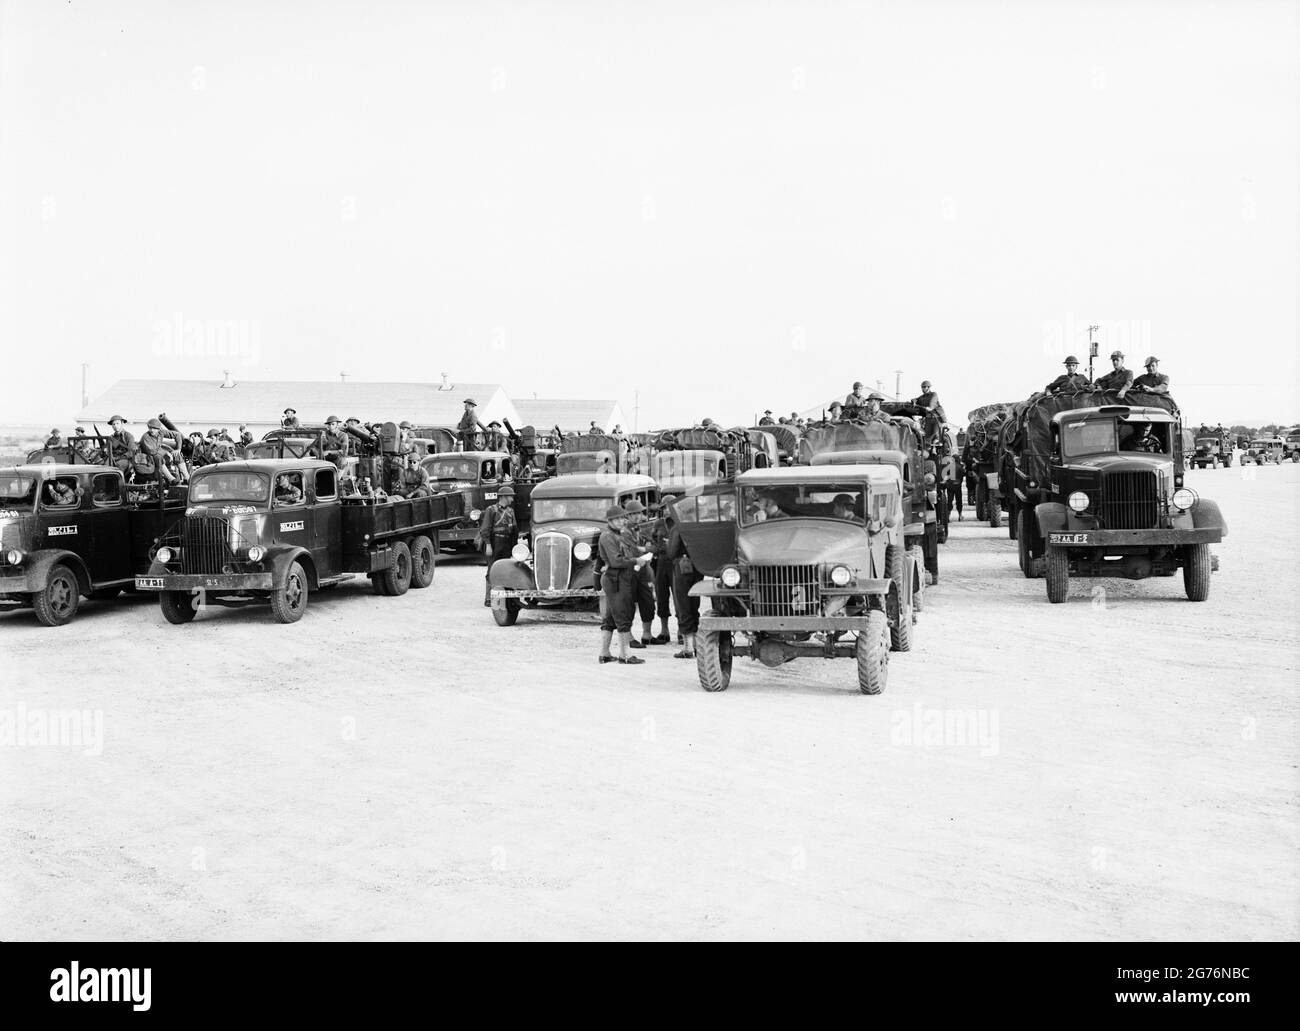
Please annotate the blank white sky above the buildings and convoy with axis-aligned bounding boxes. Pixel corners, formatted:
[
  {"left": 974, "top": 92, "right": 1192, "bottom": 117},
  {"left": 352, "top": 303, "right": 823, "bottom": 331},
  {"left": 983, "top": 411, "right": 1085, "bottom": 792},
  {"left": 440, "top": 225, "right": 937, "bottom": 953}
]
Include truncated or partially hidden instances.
[{"left": 0, "top": 0, "right": 1300, "bottom": 429}]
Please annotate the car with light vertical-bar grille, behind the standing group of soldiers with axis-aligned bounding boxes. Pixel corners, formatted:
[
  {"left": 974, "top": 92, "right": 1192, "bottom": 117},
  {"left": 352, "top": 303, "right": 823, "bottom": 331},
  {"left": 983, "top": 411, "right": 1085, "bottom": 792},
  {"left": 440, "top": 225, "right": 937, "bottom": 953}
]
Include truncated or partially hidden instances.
[{"left": 488, "top": 473, "right": 659, "bottom": 627}]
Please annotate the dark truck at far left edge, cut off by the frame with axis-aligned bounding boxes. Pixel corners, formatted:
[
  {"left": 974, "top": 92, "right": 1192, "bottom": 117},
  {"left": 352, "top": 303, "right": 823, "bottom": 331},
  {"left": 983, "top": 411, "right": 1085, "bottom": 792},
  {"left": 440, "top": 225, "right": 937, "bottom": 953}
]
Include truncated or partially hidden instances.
[{"left": 0, "top": 463, "right": 186, "bottom": 627}]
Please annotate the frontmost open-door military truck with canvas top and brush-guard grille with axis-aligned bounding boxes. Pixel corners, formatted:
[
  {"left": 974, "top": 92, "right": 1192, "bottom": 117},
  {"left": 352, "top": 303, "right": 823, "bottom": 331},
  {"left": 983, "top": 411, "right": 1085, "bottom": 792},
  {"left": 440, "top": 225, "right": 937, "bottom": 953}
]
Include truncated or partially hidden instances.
[{"left": 679, "top": 465, "right": 924, "bottom": 694}]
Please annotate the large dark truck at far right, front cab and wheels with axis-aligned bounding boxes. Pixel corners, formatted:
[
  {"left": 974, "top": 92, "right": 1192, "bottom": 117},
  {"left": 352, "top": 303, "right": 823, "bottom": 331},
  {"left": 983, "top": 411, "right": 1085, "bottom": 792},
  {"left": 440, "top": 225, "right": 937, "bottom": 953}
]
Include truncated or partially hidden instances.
[{"left": 1015, "top": 391, "right": 1227, "bottom": 605}]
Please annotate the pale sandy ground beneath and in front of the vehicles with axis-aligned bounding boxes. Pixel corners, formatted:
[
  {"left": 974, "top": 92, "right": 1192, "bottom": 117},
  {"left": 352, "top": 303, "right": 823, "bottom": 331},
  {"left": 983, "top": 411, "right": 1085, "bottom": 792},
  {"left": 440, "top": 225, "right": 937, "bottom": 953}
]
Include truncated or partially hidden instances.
[{"left": 0, "top": 464, "right": 1300, "bottom": 940}]
